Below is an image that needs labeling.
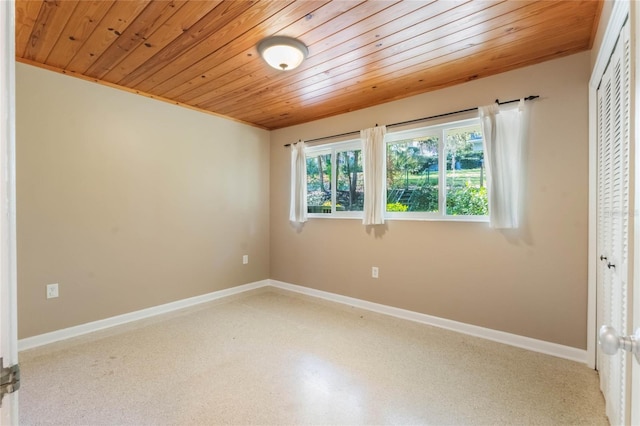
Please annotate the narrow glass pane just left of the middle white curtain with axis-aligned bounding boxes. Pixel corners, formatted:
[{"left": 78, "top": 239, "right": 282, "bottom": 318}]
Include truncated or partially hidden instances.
[{"left": 336, "top": 149, "right": 364, "bottom": 211}]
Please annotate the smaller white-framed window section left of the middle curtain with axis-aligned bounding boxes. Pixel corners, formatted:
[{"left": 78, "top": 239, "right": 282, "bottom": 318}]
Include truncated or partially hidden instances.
[{"left": 306, "top": 140, "right": 364, "bottom": 217}]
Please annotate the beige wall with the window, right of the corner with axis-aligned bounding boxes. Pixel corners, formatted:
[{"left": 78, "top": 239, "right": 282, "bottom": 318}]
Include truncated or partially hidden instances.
[{"left": 270, "top": 52, "right": 590, "bottom": 349}]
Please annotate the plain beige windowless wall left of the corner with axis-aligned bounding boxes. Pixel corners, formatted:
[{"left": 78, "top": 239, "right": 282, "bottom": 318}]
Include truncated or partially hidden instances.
[{"left": 16, "top": 64, "right": 269, "bottom": 338}]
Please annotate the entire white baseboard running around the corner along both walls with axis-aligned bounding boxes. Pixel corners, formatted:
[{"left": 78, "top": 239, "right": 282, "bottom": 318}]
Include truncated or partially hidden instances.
[{"left": 18, "top": 280, "right": 587, "bottom": 364}]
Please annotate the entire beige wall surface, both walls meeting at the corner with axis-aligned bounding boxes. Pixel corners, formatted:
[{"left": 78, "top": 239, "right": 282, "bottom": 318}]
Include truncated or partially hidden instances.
[{"left": 17, "top": 52, "right": 590, "bottom": 348}]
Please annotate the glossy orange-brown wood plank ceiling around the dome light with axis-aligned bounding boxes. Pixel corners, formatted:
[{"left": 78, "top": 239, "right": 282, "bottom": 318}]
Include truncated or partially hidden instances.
[{"left": 16, "top": 0, "right": 602, "bottom": 129}]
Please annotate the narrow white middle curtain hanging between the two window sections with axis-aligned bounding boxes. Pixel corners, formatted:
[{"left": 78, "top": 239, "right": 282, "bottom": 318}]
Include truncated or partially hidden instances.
[{"left": 360, "top": 126, "right": 387, "bottom": 225}]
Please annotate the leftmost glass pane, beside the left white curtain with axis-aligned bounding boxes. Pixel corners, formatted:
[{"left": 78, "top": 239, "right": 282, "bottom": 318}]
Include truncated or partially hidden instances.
[{"left": 307, "top": 154, "right": 331, "bottom": 213}]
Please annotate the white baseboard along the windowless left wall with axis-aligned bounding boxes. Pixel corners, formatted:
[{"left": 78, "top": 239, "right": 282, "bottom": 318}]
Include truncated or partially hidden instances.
[{"left": 18, "top": 280, "right": 269, "bottom": 351}]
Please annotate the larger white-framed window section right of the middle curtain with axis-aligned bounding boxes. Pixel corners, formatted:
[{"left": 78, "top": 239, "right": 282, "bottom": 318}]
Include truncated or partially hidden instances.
[{"left": 385, "top": 119, "right": 489, "bottom": 219}]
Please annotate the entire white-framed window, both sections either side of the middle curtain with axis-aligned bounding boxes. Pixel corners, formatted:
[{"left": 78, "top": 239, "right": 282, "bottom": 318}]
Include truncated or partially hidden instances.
[{"left": 306, "top": 119, "right": 488, "bottom": 220}]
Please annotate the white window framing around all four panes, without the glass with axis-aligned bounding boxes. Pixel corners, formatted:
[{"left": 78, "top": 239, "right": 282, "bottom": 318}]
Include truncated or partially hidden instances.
[{"left": 305, "top": 118, "right": 489, "bottom": 222}]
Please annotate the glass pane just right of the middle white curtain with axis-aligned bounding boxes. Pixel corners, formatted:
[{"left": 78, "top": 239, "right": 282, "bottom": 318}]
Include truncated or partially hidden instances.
[{"left": 387, "top": 136, "right": 438, "bottom": 212}]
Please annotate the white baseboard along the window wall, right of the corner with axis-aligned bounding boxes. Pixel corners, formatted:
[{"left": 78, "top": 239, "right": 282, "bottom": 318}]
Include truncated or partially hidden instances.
[{"left": 269, "top": 280, "right": 587, "bottom": 364}]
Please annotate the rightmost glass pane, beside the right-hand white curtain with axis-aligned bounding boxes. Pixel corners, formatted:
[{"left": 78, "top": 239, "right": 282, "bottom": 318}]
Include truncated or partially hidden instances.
[{"left": 445, "top": 125, "right": 489, "bottom": 216}]
